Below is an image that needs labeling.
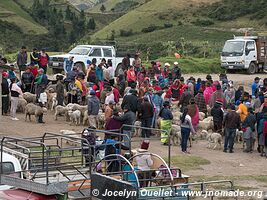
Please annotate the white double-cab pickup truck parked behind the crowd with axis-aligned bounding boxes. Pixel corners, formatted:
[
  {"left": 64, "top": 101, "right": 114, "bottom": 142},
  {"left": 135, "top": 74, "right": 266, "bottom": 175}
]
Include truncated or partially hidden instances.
[{"left": 49, "top": 45, "right": 132, "bottom": 76}]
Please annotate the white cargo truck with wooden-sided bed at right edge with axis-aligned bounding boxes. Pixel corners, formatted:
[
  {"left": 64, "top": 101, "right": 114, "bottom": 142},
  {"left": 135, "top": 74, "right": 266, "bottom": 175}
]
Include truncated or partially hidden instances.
[{"left": 221, "top": 36, "right": 267, "bottom": 74}]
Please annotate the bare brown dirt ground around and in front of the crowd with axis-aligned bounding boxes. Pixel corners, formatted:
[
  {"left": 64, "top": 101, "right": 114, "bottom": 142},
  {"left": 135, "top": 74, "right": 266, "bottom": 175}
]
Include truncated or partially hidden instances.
[{"left": 0, "top": 74, "right": 267, "bottom": 198}]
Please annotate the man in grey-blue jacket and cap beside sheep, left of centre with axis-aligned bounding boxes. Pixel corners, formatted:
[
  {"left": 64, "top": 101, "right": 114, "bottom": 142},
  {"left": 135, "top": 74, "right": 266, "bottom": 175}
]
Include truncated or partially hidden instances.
[{"left": 88, "top": 90, "right": 100, "bottom": 128}]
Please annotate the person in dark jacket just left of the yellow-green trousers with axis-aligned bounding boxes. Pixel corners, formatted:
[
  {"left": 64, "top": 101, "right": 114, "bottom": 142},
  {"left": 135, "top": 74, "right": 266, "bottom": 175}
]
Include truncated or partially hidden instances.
[{"left": 139, "top": 96, "right": 154, "bottom": 138}]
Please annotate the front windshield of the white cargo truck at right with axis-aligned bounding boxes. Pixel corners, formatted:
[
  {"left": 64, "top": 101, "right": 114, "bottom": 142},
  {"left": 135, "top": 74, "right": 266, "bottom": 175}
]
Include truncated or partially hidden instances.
[{"left": 222, "top": 41, "right": 245, "bottom": 56}]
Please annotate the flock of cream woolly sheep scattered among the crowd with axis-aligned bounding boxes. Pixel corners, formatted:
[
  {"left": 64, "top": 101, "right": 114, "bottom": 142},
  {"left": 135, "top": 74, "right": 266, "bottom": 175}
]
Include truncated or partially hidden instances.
[{"left": 17, "top": 85, "right": 245, "bottom": 149}]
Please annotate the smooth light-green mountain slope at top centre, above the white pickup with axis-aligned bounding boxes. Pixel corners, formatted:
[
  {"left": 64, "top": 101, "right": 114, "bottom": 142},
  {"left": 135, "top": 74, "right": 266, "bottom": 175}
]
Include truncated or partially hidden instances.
[{"left": 93, "top": 0, "right": 219, "bottom": 39}]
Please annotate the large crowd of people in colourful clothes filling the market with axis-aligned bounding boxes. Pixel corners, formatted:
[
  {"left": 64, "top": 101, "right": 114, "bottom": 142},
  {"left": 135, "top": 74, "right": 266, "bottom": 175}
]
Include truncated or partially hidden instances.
[{"left": 1, "top": 47, "right": 267, "bottom": 156}]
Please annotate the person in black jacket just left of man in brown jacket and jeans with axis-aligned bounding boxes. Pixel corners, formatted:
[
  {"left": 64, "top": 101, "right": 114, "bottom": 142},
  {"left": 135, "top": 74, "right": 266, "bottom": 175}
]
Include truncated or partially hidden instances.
[{"left": 211, "top": 101, "right": 223, "bottom": 133}]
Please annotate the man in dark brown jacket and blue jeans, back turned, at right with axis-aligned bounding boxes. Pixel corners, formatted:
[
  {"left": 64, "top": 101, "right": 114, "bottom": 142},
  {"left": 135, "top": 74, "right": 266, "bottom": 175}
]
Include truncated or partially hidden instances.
[{"left": 223, "top": 104, "right": 241, "bottom": 153}]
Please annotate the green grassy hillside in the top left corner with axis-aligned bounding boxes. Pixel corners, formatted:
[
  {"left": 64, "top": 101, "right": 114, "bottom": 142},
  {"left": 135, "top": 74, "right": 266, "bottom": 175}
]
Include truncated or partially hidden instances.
[{"left": 0, "top": 0, "right": 47, "bottom": 34}]
